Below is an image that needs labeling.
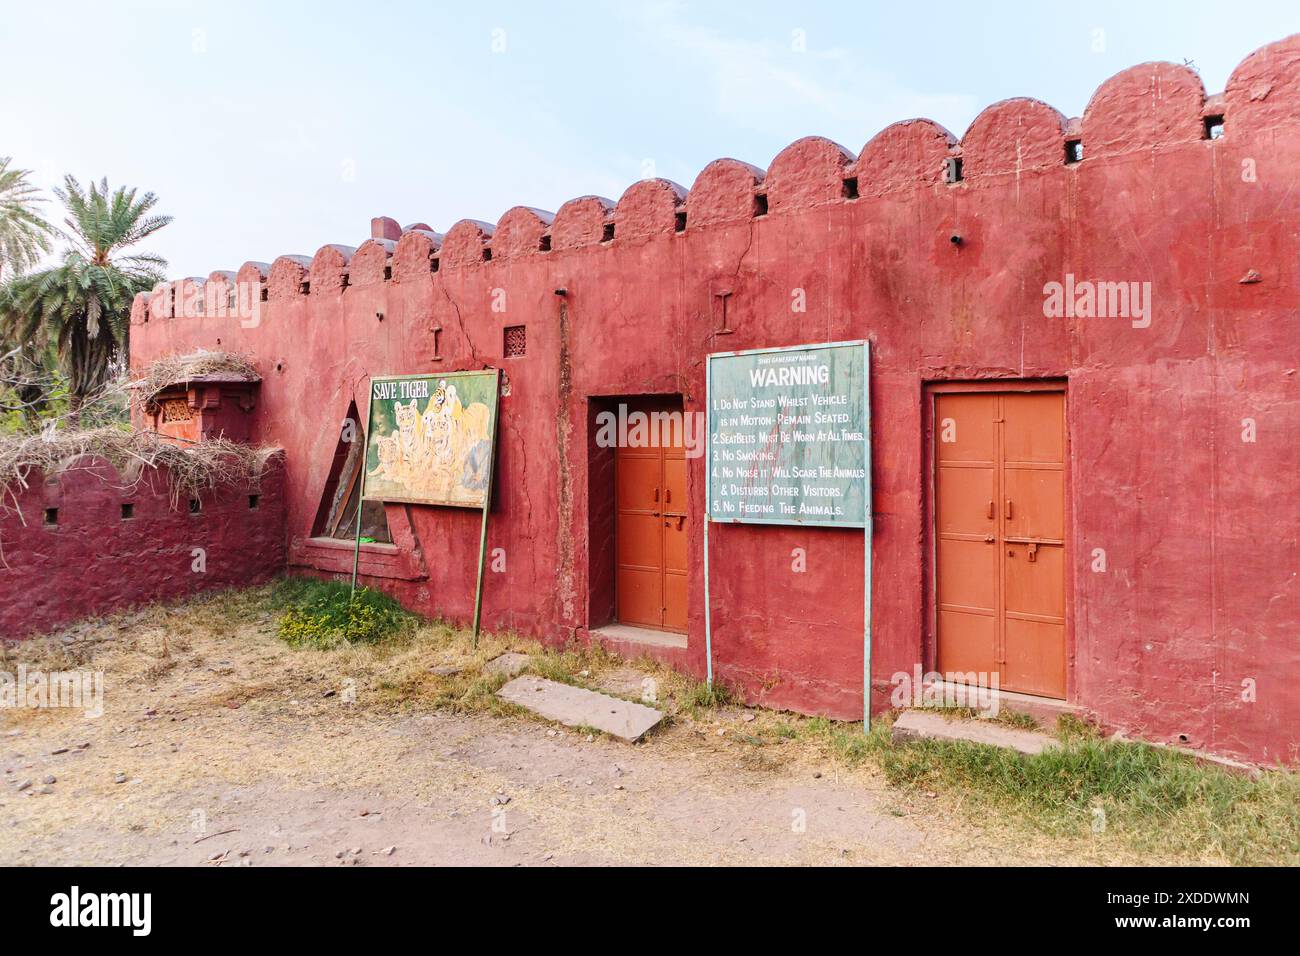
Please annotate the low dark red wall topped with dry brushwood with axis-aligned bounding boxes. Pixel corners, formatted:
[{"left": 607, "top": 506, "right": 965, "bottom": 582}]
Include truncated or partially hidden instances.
[{"left": 0, "top": 458, "right": 285, "bottom": 639}]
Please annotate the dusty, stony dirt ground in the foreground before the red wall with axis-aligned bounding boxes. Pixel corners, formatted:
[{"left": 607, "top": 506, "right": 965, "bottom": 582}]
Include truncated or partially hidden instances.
[{"left": 0, "top": 598, "right": 1185, "bottom": 866}]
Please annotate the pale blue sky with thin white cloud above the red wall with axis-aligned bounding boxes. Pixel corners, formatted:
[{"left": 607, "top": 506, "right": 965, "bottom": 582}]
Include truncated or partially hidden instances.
[{"left": 0, "top": 0, "right": 1300, "bottom": 276}]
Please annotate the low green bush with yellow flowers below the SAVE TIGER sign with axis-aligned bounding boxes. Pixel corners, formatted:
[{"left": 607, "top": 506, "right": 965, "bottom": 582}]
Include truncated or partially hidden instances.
[{"left": 272, "top": 578, "right": 415, "bottom": 649}]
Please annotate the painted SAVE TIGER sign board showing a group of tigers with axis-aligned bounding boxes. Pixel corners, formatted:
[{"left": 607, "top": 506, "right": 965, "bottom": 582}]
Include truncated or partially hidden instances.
[{"left": 365, "top": 369, "right": 498, "bottom": 507}]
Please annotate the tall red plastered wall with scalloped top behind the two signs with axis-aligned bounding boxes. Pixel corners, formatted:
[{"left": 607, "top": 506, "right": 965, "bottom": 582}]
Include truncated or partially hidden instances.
[{"left": 131, "top": 38, "right": 1300, "bottom": 761}]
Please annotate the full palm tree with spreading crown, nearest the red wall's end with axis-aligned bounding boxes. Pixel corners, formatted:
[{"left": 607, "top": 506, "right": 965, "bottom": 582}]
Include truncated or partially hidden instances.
[{"left": 0, "top": 176, "right": 172, "bottom": 421}]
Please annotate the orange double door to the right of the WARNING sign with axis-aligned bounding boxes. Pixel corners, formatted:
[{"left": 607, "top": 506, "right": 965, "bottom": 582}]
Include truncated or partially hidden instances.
[{"left": 933, "top": 389, "right": 1066, "bottom": 698}]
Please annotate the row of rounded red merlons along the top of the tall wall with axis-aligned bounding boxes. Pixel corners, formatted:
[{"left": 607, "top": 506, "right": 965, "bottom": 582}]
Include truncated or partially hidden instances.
[{"left": 131, "top": 35, "right": 1300, "bottom": 317}]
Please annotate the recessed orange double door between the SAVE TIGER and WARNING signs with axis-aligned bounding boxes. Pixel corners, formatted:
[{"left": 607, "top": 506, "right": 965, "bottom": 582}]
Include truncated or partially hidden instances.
[{"left": 615, "top": 405, "right": 689, "bottom": 632}]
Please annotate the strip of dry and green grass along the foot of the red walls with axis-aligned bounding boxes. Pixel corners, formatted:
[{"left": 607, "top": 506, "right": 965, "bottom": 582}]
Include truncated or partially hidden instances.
[{"left": 8, "top": 583, "right": 1300, "bottom": 865}]
